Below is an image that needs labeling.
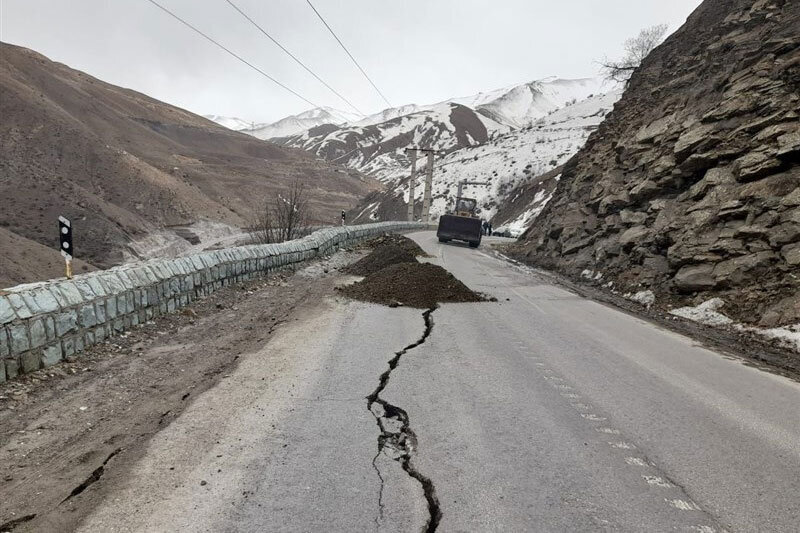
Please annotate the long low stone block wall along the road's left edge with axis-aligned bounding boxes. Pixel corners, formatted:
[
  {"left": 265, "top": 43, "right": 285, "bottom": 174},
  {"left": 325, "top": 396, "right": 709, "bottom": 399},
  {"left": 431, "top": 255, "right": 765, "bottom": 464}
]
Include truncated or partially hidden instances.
[{"left": 0, "top": 222, "right": 425, "bottom": 383}]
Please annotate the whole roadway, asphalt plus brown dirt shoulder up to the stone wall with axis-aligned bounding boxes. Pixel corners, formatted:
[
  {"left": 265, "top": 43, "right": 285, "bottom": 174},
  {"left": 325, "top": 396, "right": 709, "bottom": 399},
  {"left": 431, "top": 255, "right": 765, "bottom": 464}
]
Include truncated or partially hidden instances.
[{"left": 0, "top": 232, "right": 800, "bottom": 532}]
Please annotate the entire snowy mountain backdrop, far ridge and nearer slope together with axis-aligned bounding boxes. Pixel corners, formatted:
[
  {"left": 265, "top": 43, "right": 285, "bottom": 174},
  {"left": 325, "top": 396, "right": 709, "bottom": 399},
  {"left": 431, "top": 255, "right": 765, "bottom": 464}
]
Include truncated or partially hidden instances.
[{"left": 217, "top": 78, "right": 621, "bottom": 236}]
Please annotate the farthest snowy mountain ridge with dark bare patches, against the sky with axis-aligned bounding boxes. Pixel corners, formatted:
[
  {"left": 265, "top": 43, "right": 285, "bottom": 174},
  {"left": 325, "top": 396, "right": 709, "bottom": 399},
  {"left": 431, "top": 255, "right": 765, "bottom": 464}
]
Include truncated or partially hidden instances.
[{"left": 272, "top": 78, "right": 603, "bottom": 181}]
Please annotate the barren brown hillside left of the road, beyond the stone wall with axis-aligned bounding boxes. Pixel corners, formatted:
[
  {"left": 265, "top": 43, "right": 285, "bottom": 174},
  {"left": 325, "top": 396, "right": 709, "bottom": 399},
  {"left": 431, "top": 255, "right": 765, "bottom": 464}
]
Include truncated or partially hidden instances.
[{"left": 0, "top": 43, "right": 378, "bottom": 274}]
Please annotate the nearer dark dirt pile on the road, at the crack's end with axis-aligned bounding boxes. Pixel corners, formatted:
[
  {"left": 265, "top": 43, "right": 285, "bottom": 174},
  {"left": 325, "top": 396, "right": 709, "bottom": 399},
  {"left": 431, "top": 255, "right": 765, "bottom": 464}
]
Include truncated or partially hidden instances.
[{"left": 340, "top": 261, "right": 484, "bottom": 309}]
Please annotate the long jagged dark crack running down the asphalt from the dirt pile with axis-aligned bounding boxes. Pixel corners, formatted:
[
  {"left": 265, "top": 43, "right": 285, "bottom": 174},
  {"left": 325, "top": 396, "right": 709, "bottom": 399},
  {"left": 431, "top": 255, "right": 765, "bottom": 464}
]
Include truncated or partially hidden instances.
[{"left": 367, "top": 307, "right": 442, "bottom": 533}]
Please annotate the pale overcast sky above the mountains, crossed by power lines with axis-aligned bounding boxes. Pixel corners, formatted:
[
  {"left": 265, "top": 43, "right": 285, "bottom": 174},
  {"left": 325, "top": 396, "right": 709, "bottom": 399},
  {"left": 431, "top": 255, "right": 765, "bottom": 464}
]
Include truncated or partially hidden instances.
[{"left": 0, "top": 0, "right": 701, "bottom": 121}]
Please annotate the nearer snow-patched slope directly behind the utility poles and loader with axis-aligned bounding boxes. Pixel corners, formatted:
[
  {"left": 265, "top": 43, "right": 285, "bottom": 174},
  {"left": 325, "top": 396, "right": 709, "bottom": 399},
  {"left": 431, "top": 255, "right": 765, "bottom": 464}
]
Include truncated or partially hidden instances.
[{"left": 353, "top": 89, "right": 621, "bottom": 235}]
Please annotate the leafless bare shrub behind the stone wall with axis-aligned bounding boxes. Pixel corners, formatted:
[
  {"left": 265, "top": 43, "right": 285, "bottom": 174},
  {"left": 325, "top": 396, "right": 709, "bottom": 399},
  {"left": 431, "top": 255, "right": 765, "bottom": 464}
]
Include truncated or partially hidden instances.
[{"left": 250, "top": 181, "right": 313, "bottom": 244}]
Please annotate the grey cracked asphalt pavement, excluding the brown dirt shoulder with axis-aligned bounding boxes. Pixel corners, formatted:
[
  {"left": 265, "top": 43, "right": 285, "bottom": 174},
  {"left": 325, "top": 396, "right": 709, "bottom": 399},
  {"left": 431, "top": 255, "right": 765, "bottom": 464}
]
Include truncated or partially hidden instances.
[{"left": 72, "top": 232, "right": 800, "bottom": 531}]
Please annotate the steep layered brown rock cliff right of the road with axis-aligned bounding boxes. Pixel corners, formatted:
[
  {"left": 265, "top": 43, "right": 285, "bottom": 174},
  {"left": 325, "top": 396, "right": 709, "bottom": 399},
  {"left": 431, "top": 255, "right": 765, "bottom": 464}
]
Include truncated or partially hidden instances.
[{"left": 516, "top": 0, "right": 800, "bottom": 326}]
